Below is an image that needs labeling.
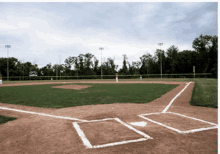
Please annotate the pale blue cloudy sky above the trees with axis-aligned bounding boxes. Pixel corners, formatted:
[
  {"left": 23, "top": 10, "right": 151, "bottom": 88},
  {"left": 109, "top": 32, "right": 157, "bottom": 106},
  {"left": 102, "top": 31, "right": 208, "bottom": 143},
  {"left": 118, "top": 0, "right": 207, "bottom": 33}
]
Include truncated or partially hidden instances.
[{"left": 0, "top": 2, "right": 218, "bottom": 69}]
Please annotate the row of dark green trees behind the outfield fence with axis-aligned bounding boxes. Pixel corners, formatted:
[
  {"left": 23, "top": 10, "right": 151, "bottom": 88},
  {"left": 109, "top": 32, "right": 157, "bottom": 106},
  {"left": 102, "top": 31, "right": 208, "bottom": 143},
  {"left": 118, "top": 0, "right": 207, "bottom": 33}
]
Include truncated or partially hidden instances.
[{"left": 0, "top": 35, "right": 218, "bottom": 78}]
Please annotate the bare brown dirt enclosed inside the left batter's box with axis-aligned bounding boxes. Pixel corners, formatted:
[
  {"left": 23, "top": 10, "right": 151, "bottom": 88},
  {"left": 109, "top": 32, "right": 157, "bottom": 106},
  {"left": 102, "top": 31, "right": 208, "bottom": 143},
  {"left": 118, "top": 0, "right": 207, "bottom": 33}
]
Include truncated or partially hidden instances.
[{"left": 79, "top": 120, "right": 143, "bottom": 145}]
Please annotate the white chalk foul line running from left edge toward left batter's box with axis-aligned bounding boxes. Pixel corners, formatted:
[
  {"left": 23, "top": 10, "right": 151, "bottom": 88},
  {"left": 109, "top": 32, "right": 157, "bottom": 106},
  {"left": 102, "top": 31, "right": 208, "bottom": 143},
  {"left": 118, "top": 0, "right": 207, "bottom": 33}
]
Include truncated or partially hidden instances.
[{"left": 0, "top": 107, "right": 87, "bottom": 122}]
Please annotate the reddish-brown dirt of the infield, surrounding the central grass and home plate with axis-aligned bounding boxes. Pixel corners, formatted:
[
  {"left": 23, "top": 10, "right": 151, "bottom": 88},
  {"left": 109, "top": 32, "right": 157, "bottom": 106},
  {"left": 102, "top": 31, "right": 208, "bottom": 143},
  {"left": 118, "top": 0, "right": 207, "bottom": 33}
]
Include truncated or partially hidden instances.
[{"left": 0, "top": 81, "right": 218, "bottom": 154}]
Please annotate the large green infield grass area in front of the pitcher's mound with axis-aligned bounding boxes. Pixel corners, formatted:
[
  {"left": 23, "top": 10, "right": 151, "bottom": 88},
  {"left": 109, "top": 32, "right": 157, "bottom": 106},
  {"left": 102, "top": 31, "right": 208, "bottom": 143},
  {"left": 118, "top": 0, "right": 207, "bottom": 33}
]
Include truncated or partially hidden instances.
[{"left": 0, "top": 83, "right": 177, "bottom": 108}]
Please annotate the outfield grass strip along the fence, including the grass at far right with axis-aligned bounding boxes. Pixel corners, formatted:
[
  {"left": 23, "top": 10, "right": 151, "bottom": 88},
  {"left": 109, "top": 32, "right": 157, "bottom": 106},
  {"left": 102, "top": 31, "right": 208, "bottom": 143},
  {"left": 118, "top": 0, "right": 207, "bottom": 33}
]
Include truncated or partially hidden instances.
[{"left": 0, "top": 78, "right": 218, "bottom": 108}]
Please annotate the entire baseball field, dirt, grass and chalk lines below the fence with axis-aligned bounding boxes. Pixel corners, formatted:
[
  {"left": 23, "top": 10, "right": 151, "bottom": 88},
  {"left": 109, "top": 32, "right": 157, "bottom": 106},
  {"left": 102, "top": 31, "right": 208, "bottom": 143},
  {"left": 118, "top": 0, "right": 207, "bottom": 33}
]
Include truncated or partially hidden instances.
[{"left": 0, "top": 79, "right": 218, "bottom": 154}]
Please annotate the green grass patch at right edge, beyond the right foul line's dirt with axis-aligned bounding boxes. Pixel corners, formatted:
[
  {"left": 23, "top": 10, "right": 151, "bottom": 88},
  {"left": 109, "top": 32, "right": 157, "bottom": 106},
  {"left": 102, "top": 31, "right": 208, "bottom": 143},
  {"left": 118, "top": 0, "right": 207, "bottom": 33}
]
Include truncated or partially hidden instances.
[{"left": 190, "top": 79, "right": 218, "bottom": 108}]
